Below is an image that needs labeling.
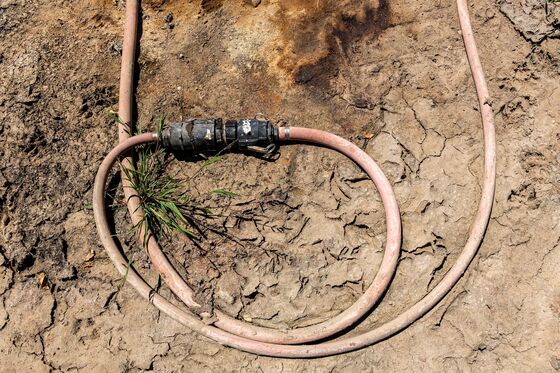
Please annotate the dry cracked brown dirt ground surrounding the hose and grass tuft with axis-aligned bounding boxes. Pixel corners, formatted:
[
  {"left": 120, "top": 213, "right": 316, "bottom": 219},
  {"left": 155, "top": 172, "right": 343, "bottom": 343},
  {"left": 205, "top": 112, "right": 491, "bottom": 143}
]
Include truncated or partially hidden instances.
[{"left": 0, "top": 0, "right": 560, "bottom": 372}]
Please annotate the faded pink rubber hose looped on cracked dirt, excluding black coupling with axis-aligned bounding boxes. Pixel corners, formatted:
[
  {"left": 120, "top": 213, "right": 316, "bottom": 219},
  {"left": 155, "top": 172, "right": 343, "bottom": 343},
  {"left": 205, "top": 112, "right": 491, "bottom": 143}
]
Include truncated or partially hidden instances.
[{"left": 93, "top": 0, "right": 496, "bottom": 358}]
